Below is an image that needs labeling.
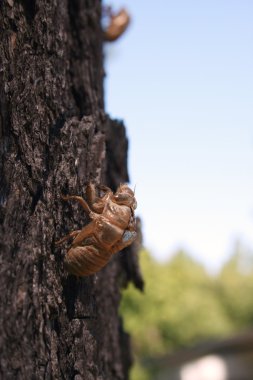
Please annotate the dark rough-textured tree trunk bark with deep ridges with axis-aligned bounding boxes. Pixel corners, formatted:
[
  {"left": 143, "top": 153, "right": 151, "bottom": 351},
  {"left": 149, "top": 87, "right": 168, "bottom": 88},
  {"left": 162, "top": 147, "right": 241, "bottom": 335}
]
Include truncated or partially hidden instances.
[{"left": 0, "top": 0, "right": 142, "bottom": 380}]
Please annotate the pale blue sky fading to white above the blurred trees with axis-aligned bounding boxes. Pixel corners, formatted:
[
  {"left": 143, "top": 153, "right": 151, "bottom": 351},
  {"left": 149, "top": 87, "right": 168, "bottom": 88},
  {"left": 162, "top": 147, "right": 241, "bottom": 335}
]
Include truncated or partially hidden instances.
[{"left": 104, "top": 0, "right": 253, "bottom": 271}]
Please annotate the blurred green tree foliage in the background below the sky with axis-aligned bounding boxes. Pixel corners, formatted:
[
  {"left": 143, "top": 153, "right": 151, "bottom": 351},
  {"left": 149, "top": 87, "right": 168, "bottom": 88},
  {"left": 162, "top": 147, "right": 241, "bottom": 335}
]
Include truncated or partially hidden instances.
[{"left": 120, "top": 245, "right": 253, "bottom": 380}]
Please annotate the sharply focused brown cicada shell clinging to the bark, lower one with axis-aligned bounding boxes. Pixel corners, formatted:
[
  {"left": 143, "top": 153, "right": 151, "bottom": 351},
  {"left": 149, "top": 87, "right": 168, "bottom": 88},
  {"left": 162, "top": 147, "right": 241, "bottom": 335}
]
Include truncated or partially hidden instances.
[{"left": 56, "top": 183, "right": 137, "bottom": 276}]
